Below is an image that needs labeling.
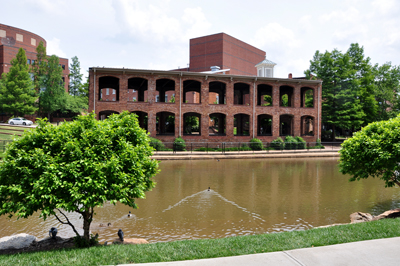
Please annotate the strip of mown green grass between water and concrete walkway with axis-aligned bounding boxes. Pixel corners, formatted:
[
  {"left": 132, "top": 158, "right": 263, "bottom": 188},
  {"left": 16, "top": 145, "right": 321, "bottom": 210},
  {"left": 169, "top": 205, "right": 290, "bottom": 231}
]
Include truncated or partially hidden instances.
[{"left": 0, "top": 219, "right": 400, "bottom": 265}]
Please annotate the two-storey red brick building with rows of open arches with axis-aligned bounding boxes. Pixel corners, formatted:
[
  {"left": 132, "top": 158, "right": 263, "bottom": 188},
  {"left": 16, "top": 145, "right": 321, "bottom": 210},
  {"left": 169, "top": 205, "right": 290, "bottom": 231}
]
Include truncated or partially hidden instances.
[{"left": 89, "top": 67, "right": 322, "bottom": 142}]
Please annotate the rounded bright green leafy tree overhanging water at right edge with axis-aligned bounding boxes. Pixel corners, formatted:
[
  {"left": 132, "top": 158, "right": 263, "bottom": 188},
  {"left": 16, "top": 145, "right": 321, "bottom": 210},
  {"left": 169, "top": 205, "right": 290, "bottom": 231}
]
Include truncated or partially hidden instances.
[{"left": 339, "top": 116, "right": 400, "bottom": 187}]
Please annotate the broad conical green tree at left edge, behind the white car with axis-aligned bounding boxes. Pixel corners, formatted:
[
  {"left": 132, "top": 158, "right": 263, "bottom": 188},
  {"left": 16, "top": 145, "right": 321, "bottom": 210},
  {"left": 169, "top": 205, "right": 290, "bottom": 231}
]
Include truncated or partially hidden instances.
[{"left": 0, "top": 48, "right": 37, "bottom": 116}]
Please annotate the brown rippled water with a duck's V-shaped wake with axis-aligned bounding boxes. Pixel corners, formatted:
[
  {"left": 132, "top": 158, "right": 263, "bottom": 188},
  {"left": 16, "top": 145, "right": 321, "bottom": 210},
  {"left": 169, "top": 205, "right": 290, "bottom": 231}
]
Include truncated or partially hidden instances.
[{"left": 0, "top": 158, "right": 400, "bottom": 242}]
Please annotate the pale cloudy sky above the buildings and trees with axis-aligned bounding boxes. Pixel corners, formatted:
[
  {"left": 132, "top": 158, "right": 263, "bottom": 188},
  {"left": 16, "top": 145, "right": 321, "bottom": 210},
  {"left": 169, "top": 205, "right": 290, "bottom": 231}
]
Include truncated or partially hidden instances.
[{"left": 0, "top": 0, "right": 400, "bottom": 78}]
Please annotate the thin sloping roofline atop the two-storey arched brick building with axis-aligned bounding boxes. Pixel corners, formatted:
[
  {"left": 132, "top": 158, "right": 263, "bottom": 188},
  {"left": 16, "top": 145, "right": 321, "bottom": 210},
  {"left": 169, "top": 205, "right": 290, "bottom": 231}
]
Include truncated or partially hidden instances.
[{"left": 89, "top": 67, "right": 322, "bottom": 84}]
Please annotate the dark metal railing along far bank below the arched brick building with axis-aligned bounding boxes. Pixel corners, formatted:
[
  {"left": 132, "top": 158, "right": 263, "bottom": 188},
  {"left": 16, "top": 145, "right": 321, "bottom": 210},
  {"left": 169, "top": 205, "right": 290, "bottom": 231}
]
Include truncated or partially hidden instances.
[{"left": 150, "top": 142, "right": 341, "bottom": 154}]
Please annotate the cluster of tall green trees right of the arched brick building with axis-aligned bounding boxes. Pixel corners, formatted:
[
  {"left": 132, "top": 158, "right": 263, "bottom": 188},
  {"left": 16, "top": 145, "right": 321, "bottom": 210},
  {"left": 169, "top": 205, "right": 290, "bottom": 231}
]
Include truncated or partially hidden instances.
[{"left": 305, "top": 43, "right": 400, "bottom": 139}]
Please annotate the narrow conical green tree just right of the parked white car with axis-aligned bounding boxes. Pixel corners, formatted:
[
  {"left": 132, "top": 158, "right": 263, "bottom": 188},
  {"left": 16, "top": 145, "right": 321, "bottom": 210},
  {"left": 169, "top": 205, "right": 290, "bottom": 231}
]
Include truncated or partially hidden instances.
[{"left": 39, "top": 55, "right": 67, "bottom": 121}]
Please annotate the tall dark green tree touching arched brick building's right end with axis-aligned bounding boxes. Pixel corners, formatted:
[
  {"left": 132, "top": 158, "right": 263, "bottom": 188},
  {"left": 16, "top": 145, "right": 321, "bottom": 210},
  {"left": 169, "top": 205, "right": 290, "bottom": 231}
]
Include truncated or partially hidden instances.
[{"left": 305, "top": 49, "right": 365, "bottom": 139}]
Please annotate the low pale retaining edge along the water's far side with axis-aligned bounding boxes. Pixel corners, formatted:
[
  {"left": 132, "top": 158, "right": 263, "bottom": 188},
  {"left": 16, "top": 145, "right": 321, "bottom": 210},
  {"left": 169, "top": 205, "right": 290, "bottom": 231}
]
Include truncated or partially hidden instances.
[{"left": 152, "top": 149, "right": 340, "bottom": 161}]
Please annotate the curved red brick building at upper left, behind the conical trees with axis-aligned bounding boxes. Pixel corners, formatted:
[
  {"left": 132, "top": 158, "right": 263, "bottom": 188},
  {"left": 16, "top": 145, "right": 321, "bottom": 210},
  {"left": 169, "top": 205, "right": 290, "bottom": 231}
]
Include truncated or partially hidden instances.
[{"left": 0, "top": 24, "right": 69, "bottom": 91}]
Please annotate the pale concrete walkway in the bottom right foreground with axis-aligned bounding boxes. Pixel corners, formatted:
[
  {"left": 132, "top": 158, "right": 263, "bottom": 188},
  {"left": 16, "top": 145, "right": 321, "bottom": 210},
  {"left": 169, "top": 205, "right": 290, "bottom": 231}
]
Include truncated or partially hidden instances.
[{"left": 124, "top": 237, "right": 400, "bottom": 266}]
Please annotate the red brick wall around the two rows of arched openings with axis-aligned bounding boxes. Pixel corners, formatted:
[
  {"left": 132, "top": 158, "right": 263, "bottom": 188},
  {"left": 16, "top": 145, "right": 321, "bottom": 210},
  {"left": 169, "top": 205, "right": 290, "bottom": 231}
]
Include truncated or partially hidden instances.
[{"left": 89, "top": 68, "right": 321, "bottom": 142}]
